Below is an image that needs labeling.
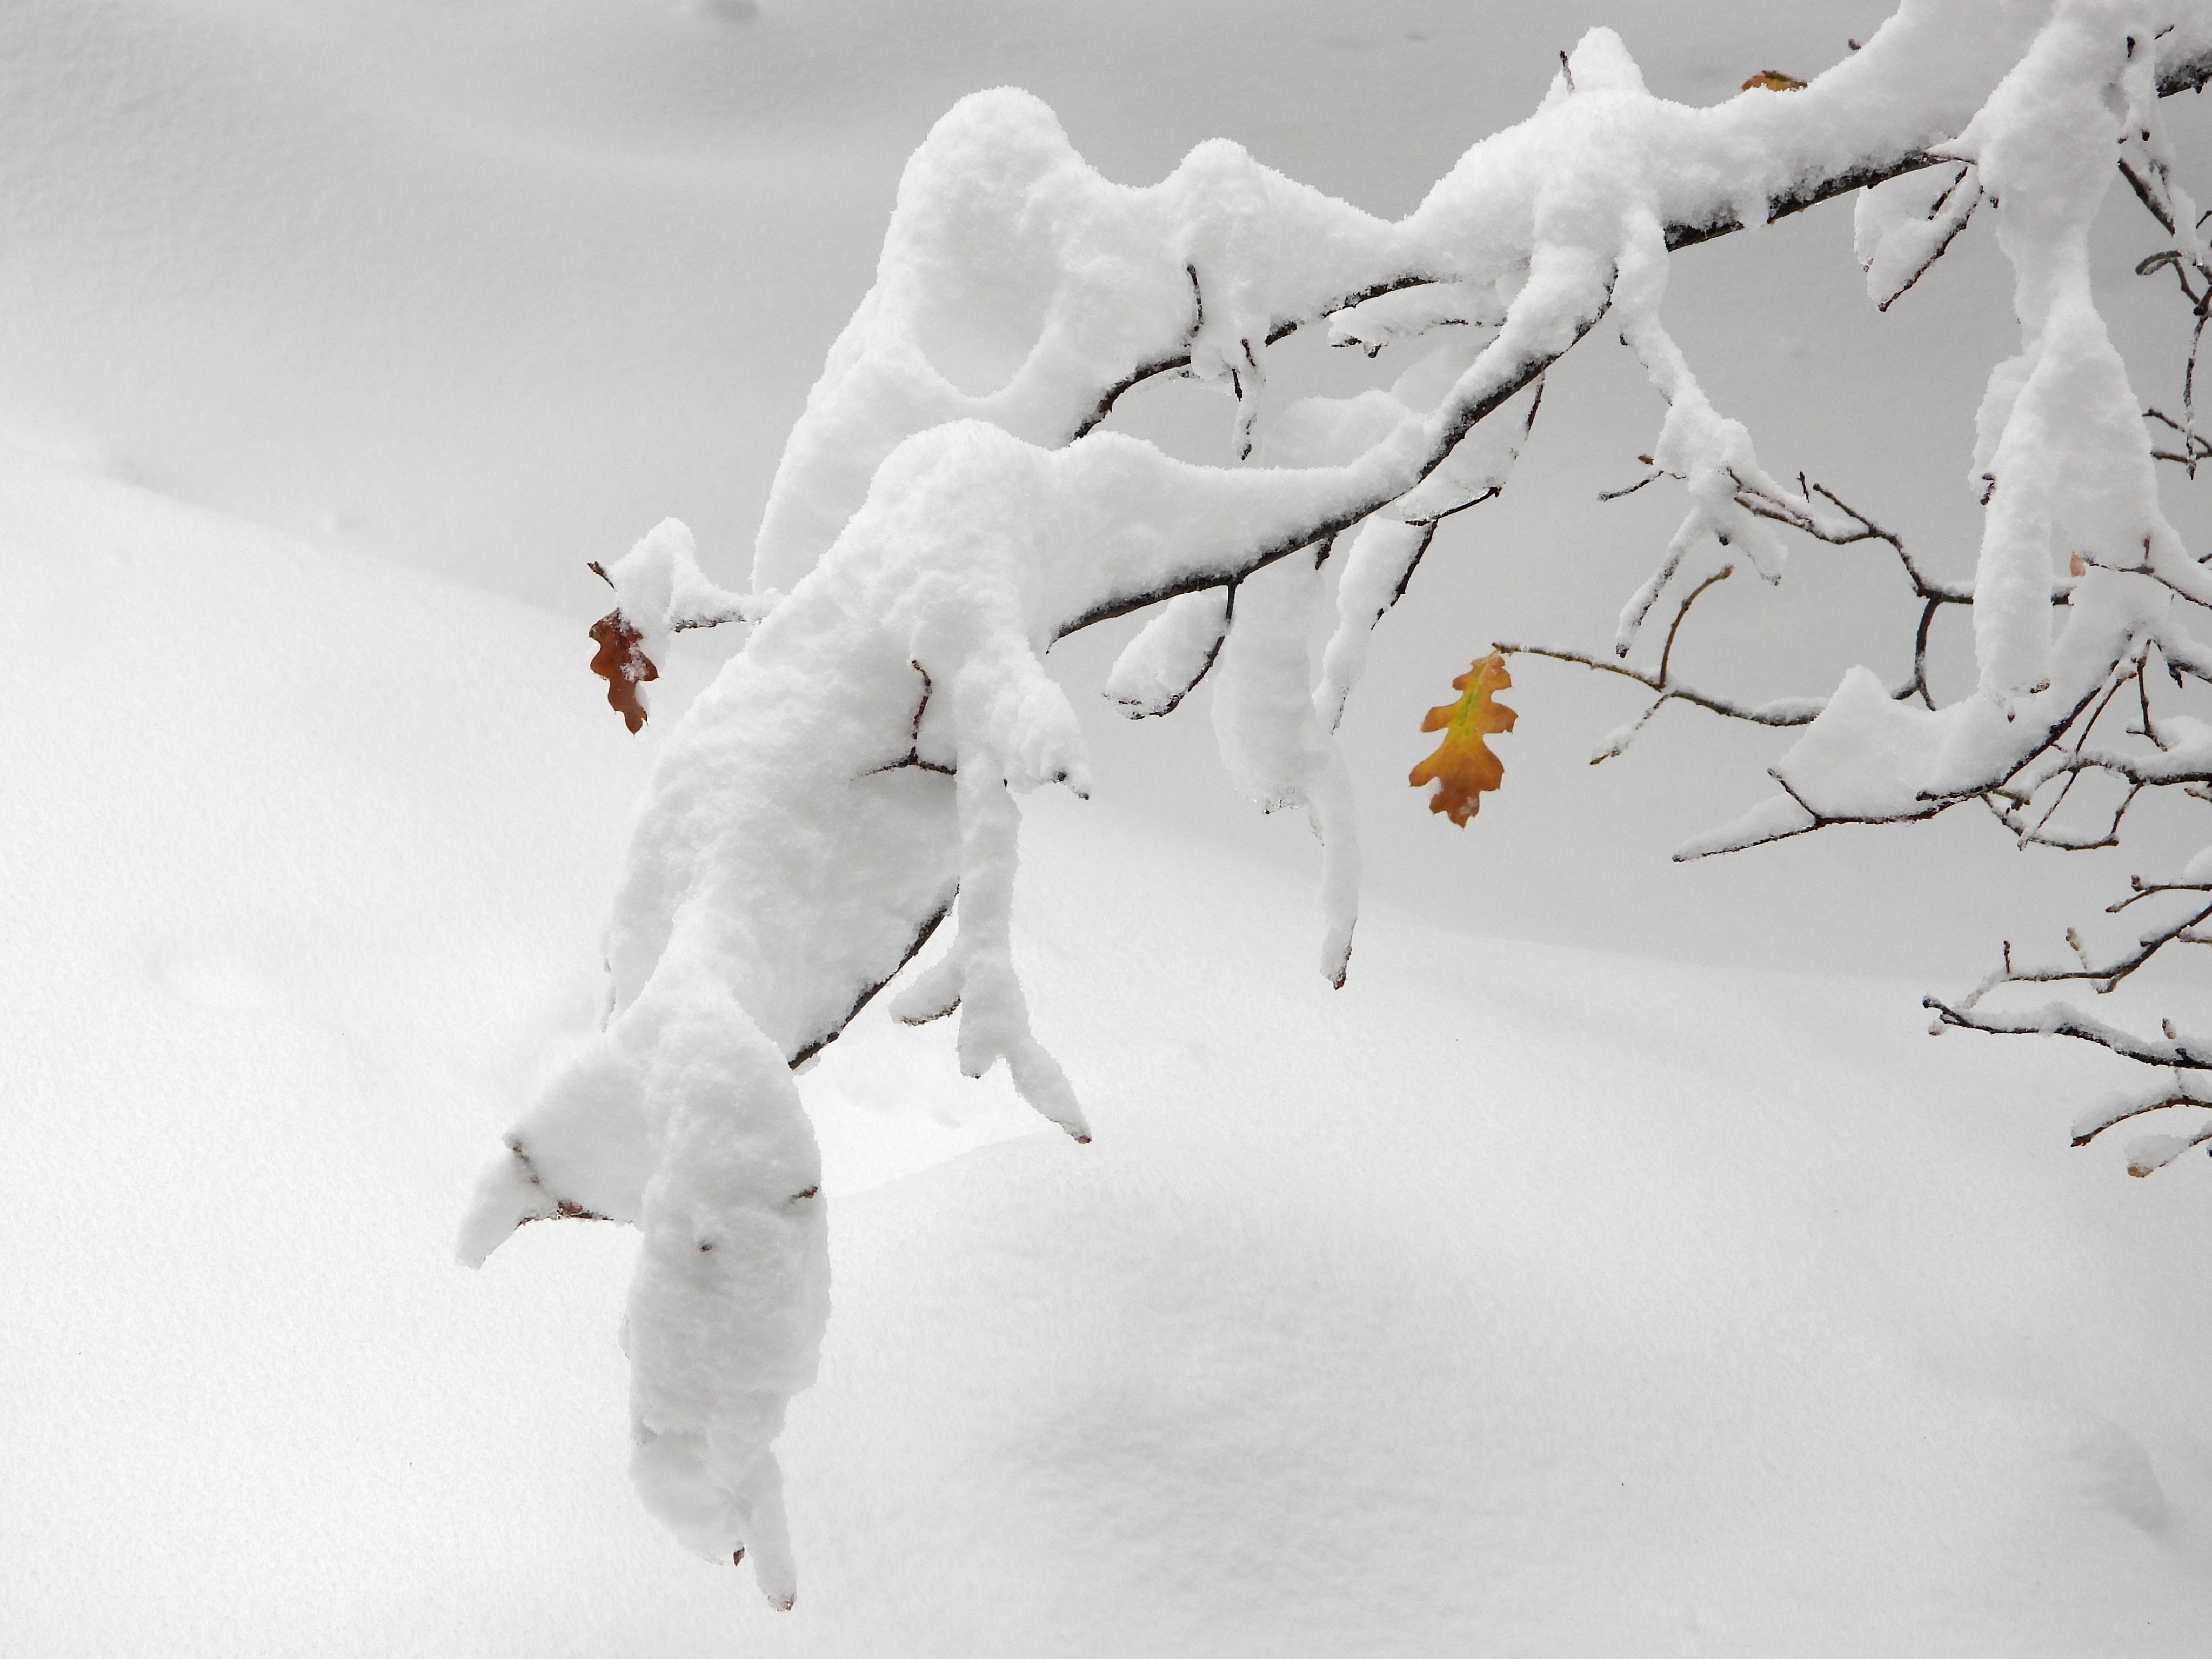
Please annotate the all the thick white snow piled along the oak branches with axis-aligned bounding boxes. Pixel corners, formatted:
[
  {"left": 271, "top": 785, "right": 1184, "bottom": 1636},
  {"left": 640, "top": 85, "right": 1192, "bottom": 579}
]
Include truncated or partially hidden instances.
[{"left": 462, "top": 0, "right": 2212, "bottom": 1606}]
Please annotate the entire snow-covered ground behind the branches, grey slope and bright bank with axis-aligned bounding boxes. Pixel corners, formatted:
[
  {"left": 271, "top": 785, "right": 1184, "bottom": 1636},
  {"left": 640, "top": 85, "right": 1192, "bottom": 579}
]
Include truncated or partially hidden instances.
[{"left": 13, "top": 0, "right": 2212, "bottom": 1659}]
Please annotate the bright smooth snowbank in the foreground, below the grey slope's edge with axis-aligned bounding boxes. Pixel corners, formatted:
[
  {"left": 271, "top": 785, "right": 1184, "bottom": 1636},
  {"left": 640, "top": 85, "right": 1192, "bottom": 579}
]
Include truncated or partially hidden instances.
[{"left": 0, "top": 456, "right": 2212, "bottom": 1659}]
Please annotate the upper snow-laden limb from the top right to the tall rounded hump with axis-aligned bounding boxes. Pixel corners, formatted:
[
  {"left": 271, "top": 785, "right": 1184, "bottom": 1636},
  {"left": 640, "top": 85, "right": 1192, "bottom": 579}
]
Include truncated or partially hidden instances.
[{"left": 754, "top": 11, "right": 2150, "bottom": 606}]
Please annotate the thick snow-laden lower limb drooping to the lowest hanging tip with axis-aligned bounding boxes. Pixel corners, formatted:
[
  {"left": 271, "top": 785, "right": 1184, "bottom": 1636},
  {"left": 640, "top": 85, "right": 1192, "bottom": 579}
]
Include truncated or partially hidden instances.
[{"left": 462, "top": 290, "right": 1608, "bottom": 1604}]
